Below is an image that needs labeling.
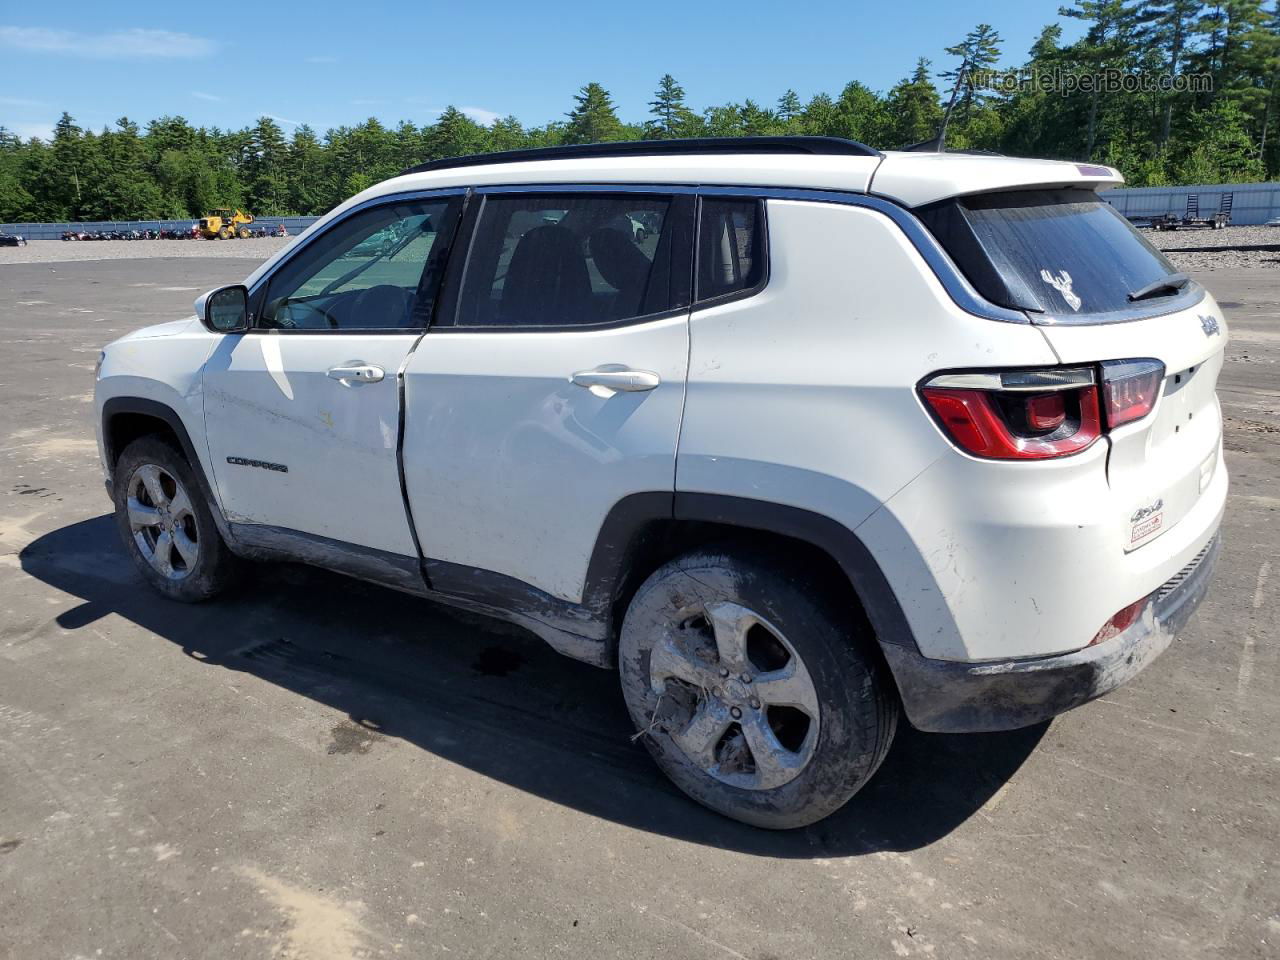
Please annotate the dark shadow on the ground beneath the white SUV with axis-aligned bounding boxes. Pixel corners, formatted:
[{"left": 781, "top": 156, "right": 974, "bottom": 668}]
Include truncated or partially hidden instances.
[{"left": 19, "top": 516, "right": 1048, "bottom": 858}]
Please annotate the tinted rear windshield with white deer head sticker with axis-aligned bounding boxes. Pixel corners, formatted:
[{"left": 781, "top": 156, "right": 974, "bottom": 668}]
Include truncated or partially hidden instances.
[{"left": 916, "top": 189, "right": 1178, "bottom": 316}]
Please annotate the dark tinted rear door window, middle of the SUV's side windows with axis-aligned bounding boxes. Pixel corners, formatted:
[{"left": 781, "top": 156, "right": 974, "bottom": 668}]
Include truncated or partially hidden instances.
[{"left": 457, "top": 195, "right": 689, "bottom": 326}]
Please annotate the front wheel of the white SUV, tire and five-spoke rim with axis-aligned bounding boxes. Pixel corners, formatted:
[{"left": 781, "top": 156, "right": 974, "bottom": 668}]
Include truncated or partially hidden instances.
[{"left": 111, "top": 436, "right": 237, "bottom": 603}]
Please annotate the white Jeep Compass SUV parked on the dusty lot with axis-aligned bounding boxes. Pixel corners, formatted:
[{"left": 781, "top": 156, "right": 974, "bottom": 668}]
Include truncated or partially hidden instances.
[{"left": 96, "top": 137, "right": 1228, "bottom": 827}]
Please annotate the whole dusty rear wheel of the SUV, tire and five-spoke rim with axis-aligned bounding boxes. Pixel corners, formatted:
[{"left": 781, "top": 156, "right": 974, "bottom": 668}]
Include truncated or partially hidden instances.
[{"left": 618, "top": 550, "right": 899, "bottom": 829}]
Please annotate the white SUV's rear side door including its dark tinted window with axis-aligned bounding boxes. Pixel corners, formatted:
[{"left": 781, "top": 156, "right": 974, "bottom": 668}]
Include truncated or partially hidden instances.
[{"left": 404, "top": 188, "right": 692, "bottom": 602}]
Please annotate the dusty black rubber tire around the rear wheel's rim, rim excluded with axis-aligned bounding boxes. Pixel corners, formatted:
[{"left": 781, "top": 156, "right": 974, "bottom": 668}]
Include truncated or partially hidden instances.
[{"left": 618, "top": 550, "right": 897, "bottom": 829}]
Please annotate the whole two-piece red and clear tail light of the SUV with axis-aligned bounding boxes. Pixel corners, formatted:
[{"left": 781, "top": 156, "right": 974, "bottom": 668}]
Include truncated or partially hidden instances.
[{"left": 920, "top": 360, "right": 1165, "bottom": 460}]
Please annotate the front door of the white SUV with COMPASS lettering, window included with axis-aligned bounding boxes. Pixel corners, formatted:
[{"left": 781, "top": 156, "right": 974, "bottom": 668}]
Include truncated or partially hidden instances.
[{"left": 204, "top": 196, "right": 461, "bottom": 557}]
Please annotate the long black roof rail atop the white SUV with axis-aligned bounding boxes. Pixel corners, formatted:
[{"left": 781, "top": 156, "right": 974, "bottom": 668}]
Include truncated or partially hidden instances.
[{"left": 399, "top": 137, "right": 881, "bottom": 177}]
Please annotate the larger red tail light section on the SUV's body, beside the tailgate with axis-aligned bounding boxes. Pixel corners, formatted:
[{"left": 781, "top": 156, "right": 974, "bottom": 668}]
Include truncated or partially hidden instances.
[{"left": 920, "top": 367, "right": 1102, "bottom": 460}]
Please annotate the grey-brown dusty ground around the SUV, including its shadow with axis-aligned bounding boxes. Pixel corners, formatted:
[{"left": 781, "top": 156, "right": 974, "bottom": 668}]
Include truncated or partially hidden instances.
[{"left": 0, "top": 253, "right": 1280, "bottom": 960}]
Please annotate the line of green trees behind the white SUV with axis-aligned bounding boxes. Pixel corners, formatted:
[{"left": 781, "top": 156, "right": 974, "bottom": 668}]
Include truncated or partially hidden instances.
[{"left": 0, "top": 0, "right": 1280, "bottom": 221}]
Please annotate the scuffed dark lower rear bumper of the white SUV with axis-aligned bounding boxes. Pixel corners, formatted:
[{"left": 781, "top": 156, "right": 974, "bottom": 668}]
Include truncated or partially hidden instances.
[{"left": 881, "top": 531, "right": 1221, "bottom": 733}]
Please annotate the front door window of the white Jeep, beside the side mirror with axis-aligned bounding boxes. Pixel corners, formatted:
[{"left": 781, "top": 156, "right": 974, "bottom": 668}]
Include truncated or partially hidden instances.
[{"left": 257, "top": 198, "right": 460, "bottom": 330}]
